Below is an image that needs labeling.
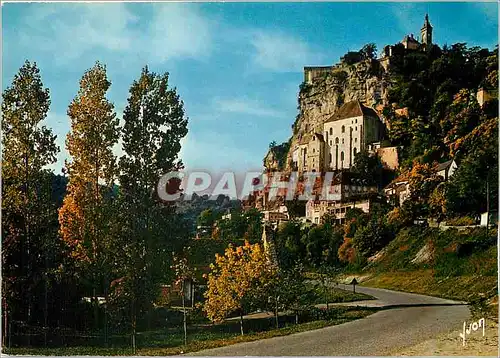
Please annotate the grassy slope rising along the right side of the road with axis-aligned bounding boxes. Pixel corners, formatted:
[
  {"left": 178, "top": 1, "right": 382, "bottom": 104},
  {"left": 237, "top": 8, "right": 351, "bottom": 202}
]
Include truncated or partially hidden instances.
[{"left": 363, "top": 227, "right": 498, "bottom": 317}]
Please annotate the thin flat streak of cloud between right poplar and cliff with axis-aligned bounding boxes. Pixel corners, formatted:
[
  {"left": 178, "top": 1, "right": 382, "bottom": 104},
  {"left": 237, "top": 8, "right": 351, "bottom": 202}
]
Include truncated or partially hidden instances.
[{"left": 214, "top": 98, "right": 285, "bottom": 118}]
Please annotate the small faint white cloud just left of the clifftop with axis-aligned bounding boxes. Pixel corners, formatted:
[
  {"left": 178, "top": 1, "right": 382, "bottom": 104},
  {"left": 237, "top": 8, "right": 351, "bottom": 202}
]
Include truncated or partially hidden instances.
[{"left": 251, "top": 31, "right": 323, "bottom": 72}]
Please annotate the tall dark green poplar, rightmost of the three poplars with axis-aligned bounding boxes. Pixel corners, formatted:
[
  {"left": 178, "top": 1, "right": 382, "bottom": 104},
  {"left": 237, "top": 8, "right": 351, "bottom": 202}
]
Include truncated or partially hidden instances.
[{"left": 115, "top": 67, "right": 188, "bottom": 344}]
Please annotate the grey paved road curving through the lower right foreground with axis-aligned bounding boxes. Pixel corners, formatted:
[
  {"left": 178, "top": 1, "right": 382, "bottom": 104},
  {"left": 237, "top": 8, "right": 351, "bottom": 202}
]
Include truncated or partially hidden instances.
[{"left": 189, "top": 285, "right": 470, "bottom": 356}]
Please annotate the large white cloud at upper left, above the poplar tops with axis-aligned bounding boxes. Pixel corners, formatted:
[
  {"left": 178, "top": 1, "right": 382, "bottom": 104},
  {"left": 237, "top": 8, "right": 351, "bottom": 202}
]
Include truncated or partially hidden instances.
[{"left": 15, "top": 3, "right": 216, "bottom": 65}]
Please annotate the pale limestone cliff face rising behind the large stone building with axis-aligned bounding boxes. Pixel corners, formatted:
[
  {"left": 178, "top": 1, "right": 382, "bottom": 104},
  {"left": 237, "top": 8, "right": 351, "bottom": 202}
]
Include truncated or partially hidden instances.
[{"left": 286, "top": 60, "right": 389, "bottom": 169}]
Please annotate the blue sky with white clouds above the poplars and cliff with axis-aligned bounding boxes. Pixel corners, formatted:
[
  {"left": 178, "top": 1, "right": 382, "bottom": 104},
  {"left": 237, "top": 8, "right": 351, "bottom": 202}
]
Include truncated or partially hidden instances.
[{"left": 2, "top": 2, "right": 498, "bottom": 173}]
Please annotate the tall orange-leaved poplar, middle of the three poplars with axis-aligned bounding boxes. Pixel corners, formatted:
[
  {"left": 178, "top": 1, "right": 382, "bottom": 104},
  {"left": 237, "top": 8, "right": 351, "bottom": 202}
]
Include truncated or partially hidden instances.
[{"left": 59, "top": 62, "right": 119, "bottom": 337}]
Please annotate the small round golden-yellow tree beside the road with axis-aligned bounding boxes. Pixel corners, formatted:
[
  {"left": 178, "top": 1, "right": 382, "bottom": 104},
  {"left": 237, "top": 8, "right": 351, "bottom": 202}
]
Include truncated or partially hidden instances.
[{"left": 204, "top": 242, "right": 275, "bottom": 335}]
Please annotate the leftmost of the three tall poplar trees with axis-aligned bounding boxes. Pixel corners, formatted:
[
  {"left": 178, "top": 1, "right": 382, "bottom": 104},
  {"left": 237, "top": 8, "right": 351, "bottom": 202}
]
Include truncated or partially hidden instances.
[{"left": 2, "top": 61, "right": 59, "bottom": 342}]
